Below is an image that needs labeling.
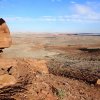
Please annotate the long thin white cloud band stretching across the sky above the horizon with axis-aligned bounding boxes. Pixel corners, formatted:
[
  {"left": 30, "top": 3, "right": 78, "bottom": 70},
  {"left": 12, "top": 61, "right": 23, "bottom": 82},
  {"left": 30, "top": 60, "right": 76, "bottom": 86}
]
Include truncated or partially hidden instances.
[{"left": 5, "top": 14, "right": 100, "bottom": 23}]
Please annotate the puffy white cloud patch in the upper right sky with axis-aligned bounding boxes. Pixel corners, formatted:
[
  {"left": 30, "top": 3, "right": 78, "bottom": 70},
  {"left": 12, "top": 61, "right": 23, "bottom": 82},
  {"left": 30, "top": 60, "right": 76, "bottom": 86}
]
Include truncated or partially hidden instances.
[{"left": 71, "top": 2, "right": 100, "bottom": 22}]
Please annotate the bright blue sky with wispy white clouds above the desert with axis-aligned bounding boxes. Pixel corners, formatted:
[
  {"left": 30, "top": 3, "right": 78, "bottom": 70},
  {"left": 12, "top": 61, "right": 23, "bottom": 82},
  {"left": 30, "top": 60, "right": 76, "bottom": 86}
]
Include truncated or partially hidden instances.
[{"left": 0, "top": 0, "right": 100, "bottom": 33}]
